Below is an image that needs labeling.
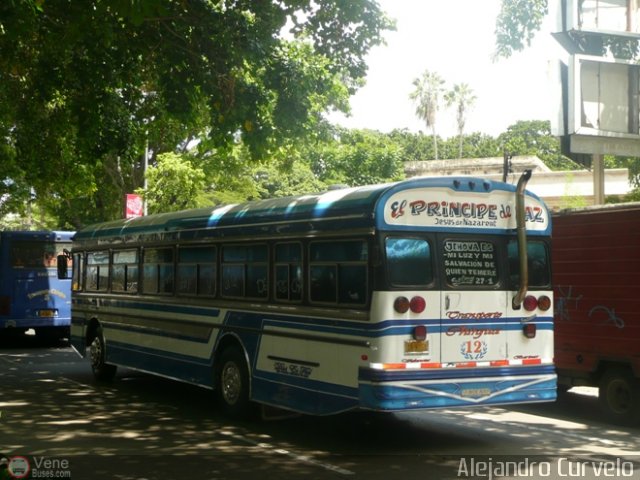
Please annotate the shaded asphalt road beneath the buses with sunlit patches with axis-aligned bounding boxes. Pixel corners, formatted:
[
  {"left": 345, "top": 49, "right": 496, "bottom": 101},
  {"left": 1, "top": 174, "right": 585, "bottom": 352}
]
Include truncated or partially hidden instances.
[{"left": 0, "top": 337, "right": 640, "bottom": 480}]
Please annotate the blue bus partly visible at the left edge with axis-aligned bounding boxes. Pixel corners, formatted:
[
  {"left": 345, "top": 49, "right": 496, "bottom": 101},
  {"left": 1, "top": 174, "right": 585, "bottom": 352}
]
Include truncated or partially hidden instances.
[{"left": 0, "top": 231, "right": 74, "bottom": 338}]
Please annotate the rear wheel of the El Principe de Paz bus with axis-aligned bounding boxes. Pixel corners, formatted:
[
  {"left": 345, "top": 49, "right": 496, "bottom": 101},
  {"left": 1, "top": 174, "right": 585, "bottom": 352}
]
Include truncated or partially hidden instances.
[{"left": 216, "top": 347, "right": 253, "bottom": 418}]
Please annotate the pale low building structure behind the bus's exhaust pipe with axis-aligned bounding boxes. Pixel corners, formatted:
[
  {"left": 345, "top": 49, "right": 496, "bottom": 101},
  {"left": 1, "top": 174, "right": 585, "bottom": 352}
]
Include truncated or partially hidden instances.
[{"left": 405, "top": 156, "right": 632, "bottom": 209}]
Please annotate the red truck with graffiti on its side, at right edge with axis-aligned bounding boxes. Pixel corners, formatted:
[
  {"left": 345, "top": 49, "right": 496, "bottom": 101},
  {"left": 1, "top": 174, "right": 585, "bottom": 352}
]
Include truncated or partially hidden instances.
[{"left": 552, "top": 203, "right": 640, "bottom": 423}]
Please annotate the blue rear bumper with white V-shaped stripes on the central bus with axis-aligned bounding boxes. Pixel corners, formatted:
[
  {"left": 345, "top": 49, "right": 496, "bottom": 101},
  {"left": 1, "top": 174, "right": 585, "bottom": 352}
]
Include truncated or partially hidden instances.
[{"left": 359, "top": 365, "right": 557, "bottom": 411}]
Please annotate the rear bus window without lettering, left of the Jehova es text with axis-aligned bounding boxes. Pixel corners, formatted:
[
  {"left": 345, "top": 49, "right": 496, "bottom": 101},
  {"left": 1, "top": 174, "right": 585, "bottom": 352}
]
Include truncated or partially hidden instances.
[{"left": 385, "top": 237, "right": 433, "bottom": 287}]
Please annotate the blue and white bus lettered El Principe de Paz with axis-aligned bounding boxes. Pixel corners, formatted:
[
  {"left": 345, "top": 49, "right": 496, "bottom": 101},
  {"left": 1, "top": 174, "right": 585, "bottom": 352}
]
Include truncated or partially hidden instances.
[{"left": 66, "top": 172, "right": 556, "bottom": 415}]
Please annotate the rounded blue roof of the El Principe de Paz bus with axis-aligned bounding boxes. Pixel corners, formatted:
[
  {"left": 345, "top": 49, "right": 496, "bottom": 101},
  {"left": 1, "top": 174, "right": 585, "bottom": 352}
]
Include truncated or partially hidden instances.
[{"left": 74, "top": 177, "right": 546, "bottom": 245}]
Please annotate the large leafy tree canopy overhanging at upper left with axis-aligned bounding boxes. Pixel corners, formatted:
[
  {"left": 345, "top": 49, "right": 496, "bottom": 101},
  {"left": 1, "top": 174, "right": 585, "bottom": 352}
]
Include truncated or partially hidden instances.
[{"left": 0, "top": 0, "right": 392, "bottom": 226}]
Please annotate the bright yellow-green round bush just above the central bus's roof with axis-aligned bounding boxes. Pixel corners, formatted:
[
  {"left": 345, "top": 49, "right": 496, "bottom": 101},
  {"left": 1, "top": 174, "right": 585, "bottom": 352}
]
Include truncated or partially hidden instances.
[{"left": 137, "top": 153, "right": 205, "bottom": 214}]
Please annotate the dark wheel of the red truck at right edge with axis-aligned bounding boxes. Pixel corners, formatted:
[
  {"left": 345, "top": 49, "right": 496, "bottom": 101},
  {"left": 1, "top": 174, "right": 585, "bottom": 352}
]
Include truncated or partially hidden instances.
[{"left": 598, "top": 368, "right": 640, "bottom": 424}]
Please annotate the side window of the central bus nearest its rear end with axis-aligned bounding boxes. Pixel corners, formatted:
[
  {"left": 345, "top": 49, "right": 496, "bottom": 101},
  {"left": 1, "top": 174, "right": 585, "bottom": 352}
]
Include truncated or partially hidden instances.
[{"left": 309, "top": 240, "right": 369, "bottom": 305}]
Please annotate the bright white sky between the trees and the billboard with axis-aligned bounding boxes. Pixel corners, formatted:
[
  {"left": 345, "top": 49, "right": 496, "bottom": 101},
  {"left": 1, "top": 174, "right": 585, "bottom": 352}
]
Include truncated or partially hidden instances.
[{"left": 329, "top": 0, "right": 562, "bottom": 138}]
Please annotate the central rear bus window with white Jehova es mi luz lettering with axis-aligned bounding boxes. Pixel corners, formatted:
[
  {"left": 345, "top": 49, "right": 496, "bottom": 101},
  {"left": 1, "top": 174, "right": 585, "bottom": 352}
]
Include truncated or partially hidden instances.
[{"left": 442, "top": 239, "right": 499, "bottom": 288}]
